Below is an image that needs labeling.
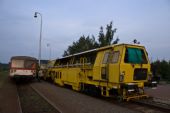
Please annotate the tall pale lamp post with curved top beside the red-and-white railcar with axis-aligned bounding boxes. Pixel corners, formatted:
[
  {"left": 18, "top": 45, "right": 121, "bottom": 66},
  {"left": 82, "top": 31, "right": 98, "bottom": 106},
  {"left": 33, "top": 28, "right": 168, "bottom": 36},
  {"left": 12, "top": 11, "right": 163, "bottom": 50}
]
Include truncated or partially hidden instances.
[{"left": 34, "top": 12, "right": 42, "bottom": 68}]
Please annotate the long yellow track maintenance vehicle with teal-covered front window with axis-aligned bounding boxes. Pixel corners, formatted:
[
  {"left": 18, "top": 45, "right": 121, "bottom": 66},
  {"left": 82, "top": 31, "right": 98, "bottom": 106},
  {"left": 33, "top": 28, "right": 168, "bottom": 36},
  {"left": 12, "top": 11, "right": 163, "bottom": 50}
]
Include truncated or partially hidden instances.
[{"left": 48, "top": 44, "right": 151, "bottom": 100}]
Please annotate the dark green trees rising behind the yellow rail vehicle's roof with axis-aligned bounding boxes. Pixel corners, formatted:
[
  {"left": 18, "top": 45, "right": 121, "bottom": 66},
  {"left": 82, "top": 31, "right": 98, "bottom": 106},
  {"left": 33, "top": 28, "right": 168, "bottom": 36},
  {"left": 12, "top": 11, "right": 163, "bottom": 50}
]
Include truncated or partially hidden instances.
[{"left": 63, "top": 21, "right": 119, "bottom": 57}]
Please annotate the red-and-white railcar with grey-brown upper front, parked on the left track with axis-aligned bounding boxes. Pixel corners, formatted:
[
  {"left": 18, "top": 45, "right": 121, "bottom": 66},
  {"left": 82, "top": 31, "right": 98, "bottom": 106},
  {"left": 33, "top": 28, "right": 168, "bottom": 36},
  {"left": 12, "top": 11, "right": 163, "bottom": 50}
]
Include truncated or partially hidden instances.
[{"left": 9, "top": 56, "right": 38, "bottom": 79}]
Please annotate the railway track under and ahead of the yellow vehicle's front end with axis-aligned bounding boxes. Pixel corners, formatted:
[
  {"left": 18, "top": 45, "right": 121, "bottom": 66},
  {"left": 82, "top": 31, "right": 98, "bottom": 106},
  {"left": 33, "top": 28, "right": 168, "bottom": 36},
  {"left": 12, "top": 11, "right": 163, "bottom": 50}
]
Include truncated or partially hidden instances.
[{"left": 99, "top": 95, "right": 170, "bottom": 113}]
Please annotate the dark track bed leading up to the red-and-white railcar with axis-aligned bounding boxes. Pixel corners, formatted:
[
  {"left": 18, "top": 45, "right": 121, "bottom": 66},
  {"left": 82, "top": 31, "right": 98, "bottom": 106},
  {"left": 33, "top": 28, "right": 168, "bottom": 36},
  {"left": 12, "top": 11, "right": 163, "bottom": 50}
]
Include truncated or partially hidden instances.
[{"left": 17, "top": 83, "right": 59, "bottom": 113}]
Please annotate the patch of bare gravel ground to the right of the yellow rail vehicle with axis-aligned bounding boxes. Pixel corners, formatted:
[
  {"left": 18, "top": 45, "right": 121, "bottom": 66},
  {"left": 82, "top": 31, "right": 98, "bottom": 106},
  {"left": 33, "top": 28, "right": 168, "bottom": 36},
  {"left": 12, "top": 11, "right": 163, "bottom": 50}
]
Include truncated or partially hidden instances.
[{"left": 145, "top": 84, "right": 170, "bottom": 100}]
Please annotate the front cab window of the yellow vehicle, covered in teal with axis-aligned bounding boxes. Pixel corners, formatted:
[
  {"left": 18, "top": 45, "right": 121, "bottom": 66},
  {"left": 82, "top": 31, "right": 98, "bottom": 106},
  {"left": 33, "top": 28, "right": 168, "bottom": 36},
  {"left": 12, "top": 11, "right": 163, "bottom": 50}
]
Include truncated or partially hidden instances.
[{"left": 124, "top": 48, "right": 147, "bottom": 64}]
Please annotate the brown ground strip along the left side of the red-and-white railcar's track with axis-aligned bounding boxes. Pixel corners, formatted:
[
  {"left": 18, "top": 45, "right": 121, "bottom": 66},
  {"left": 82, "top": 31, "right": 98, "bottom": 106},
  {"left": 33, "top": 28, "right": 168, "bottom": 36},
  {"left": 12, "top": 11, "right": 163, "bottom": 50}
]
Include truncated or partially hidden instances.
[{"left": 0, "top": 72, "right": 21, "bottom": 113}]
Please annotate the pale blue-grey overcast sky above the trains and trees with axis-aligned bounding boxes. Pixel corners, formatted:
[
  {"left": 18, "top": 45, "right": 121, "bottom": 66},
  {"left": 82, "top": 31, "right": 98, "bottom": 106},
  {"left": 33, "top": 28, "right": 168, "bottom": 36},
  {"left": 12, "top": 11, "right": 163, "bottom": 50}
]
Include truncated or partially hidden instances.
[{"left": 0, "top": 0, "right": 170, "bottom": 63}]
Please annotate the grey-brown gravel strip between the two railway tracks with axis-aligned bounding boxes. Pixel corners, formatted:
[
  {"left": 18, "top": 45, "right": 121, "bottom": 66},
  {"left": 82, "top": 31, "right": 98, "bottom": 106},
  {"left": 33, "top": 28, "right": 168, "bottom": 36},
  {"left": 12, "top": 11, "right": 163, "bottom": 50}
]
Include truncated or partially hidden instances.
[{"left": 32, "top": 81, "right": 137, "bottom": 113}]
